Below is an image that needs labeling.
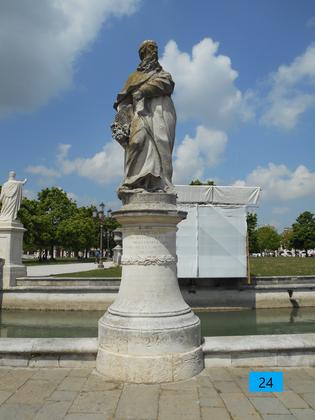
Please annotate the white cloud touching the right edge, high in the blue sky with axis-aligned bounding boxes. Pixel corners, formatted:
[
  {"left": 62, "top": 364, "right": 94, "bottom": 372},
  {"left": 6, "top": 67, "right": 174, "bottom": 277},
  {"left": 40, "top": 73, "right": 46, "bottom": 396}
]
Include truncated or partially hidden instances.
[{"left": 261, "top": 44, "right": 315, "bottom": 130}]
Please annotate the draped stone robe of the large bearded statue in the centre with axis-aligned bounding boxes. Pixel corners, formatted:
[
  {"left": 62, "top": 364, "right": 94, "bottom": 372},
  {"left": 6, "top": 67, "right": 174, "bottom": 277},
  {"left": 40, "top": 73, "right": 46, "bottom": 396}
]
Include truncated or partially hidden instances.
[{"left": 114, "top": 69, "right": 176, "bottom": 191}]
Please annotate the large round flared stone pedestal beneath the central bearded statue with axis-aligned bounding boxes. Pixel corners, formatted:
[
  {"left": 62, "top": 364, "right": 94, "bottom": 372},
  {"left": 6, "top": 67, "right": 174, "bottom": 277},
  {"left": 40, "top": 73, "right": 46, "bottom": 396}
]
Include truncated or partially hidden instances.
[{"left": 96, "top": 193, "right": 203, "bottom": 383}]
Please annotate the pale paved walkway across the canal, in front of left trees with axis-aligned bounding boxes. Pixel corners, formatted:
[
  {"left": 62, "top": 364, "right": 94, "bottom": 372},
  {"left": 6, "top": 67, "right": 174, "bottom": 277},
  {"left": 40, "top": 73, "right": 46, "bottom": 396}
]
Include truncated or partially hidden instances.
[{"left": 27, "top": 262, "right": 113, "bottom": 277}]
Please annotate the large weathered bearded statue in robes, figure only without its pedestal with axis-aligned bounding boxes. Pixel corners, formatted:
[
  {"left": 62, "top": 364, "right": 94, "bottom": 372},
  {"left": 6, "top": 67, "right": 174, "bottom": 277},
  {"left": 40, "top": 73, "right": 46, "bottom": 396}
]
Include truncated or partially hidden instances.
[{"left": 111, "top": 40, "right": 176, "bottom": 197}]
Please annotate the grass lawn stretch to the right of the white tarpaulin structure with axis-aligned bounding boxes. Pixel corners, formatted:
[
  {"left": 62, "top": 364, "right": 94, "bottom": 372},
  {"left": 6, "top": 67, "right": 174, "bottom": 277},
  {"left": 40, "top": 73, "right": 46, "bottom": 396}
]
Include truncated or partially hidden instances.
[{"left": 249, "top": 257, "right": 315, "bottom": 276}]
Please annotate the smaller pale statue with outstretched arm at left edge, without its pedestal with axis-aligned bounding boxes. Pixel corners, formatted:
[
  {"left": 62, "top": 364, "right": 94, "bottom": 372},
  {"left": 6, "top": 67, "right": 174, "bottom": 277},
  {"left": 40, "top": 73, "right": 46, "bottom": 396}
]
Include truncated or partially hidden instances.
[{"left": 0, "top": 171, "right": 27, "bottom": 220}]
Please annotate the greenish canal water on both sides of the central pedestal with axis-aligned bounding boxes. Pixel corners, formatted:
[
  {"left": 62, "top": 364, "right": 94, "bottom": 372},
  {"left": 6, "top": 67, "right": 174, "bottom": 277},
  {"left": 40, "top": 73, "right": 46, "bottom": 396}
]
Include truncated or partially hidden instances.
[{"left": 0, "top": 307, "right": 315, "bottom": 337}]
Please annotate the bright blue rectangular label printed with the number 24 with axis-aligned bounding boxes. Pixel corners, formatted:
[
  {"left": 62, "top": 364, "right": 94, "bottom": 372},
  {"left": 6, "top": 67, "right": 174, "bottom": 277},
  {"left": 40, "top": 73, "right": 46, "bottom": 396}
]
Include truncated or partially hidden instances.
[{"left": 249, "top": 372, "right": 283, "bottom": 392}]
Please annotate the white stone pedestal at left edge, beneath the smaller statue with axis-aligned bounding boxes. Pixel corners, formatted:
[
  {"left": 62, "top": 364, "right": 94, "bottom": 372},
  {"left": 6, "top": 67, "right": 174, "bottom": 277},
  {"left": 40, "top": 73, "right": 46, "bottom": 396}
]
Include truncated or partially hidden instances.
[{"left": 0, "top": 220, "right": 26, "bottom": 289}]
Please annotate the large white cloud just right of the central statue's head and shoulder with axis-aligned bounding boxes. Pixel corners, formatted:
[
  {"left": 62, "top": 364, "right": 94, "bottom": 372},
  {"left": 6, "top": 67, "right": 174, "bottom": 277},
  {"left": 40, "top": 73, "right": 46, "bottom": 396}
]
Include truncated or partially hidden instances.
[{"left": 160, "top": 38, "right": 251, "bottom": 127}]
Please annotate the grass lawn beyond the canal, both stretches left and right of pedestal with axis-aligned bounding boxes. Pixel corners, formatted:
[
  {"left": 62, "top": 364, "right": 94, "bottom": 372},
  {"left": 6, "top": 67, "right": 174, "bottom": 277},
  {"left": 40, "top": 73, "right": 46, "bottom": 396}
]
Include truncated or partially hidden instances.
[{"left": 54, "top": 257, "right": 315, "bottom": 278}]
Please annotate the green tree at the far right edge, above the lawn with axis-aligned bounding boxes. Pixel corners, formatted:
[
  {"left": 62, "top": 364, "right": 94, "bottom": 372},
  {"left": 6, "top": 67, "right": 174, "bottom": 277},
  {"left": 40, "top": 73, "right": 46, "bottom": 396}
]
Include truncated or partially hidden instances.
[{"left": 292, "top": 211, "right": 315, "bottom": 250}]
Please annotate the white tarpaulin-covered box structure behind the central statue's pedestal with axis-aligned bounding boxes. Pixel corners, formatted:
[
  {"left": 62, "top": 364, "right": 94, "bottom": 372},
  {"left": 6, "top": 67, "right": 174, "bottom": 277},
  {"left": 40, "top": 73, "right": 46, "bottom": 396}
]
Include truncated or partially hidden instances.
[{"left": 176, "top": 186, "right": 260, "bottom": 278}]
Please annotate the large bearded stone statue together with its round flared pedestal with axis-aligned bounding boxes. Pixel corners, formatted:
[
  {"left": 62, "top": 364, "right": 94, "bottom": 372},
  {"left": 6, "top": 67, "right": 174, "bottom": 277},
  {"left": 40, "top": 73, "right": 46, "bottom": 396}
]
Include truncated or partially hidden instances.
[{"left": 96, "top": 41, "right": 204, "bottom": 383}]
